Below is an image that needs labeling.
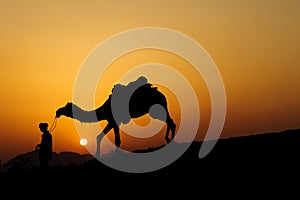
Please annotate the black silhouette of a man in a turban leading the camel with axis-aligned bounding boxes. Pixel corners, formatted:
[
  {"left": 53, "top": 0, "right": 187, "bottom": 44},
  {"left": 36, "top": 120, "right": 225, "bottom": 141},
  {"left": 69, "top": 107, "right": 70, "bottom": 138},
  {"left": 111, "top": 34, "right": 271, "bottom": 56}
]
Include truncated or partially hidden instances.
[{"left": 36, "top": 123, "right": 52, "bottom": 170}]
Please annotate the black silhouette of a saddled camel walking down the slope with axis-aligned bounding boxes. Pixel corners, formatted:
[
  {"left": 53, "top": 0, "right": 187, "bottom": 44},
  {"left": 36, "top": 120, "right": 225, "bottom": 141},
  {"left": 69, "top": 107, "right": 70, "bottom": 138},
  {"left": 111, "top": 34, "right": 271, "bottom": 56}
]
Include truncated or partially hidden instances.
[{"left": 56, "top": 76, "right": 176, "bottom": 157}]
